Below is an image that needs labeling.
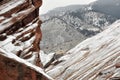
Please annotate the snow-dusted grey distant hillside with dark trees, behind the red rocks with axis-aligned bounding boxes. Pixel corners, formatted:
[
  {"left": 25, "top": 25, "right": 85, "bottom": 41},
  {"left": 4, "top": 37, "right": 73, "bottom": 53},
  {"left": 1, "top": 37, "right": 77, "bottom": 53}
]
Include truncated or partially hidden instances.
[{"left": 41, "top": 2, "right": 117, "bottom": 53}]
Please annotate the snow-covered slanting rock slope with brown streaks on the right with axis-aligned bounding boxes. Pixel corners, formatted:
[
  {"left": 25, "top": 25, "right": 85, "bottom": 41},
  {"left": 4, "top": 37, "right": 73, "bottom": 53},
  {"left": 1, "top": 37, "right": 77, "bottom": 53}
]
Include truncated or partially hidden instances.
[{"left": 47, "top": 21, "right": 120, "bottom": 80}]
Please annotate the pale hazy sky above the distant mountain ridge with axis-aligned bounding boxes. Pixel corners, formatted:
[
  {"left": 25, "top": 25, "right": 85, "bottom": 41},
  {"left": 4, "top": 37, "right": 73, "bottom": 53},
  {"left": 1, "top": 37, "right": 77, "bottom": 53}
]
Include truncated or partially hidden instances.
[{"left": 40, "top": 0, "right": 96, "bottom": 14}]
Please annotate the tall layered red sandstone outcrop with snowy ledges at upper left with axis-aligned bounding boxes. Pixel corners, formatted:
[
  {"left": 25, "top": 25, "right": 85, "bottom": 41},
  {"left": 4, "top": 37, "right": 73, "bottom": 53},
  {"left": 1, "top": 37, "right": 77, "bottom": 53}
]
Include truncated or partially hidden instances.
[{"left": 0, "top": 0, "right": 42, "bottom": 64}]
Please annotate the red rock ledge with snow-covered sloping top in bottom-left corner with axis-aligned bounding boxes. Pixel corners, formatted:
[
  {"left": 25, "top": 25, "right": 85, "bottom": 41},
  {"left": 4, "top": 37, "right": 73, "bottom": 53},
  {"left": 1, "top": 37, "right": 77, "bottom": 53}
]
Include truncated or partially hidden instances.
[{"left": 0, "top": 48, "right": 54, "bottom": 80}]
